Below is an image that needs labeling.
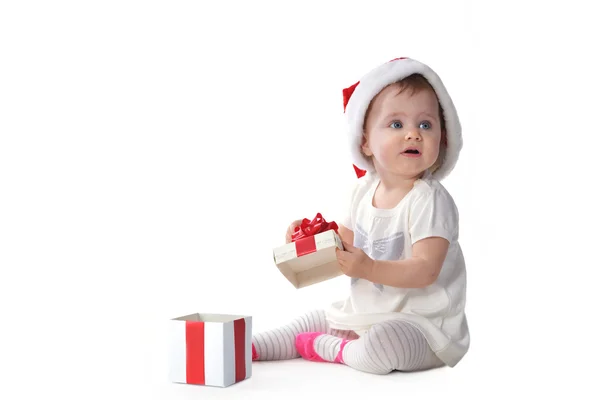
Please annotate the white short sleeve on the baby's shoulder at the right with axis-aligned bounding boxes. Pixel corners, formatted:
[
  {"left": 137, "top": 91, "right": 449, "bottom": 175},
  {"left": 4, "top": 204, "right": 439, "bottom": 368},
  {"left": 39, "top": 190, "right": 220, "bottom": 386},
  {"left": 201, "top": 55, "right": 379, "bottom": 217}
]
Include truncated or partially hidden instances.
[{"left": 408, "top": 188, "right": 458, "bottom": 244}]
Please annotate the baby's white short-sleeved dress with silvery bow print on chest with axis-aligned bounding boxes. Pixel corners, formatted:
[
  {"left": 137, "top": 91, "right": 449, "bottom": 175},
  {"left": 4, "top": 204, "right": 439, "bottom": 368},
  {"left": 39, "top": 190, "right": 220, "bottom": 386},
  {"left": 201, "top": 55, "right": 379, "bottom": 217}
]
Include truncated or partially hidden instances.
[{"left": 326, "top": 173, "right": 470, "bottom": 367}]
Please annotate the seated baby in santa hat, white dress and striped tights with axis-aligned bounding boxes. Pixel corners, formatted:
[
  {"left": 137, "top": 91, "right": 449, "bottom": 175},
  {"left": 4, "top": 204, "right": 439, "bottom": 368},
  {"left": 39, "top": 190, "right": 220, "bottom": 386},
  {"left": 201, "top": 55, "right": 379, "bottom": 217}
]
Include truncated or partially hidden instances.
[{"left": 252, "top": 58, "right": 470, "bottom": 374}]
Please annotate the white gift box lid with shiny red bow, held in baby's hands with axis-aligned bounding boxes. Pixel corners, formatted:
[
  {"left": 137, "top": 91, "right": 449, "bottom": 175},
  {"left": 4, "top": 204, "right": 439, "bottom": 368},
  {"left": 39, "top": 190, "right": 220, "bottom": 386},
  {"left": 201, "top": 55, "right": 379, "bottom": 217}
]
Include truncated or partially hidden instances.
[{"left": 273, "top": 213, "right": 344, "bottom": 289}]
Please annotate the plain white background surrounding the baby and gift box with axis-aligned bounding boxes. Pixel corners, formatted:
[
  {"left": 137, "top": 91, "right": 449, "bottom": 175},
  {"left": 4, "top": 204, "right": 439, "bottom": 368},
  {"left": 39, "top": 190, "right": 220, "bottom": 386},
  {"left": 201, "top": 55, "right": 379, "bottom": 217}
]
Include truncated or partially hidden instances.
[{"left": 0, "top": 0, "right": 600, "bottom": 399}]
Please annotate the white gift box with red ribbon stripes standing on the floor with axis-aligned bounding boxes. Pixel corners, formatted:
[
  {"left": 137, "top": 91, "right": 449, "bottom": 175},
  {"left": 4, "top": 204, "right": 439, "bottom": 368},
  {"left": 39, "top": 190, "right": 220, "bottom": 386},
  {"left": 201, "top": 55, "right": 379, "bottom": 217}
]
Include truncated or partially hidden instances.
[{"left": 169, "top": 314, "right": 252, "bottom": 387}]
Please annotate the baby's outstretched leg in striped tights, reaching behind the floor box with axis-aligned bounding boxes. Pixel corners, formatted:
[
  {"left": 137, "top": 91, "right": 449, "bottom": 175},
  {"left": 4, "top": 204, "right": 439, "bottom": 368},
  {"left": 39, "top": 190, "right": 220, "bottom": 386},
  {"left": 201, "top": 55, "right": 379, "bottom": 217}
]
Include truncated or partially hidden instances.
[{"left": 252, "top": 310, "right": 349, "bottom": 361}]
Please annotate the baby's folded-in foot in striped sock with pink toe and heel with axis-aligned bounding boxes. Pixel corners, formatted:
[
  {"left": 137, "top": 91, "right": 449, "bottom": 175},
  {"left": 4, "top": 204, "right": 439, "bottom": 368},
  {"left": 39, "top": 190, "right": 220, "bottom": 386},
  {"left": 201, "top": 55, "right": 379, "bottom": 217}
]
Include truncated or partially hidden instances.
[{"left": 296, "top": 332, "right": 349, "bottom": 364}]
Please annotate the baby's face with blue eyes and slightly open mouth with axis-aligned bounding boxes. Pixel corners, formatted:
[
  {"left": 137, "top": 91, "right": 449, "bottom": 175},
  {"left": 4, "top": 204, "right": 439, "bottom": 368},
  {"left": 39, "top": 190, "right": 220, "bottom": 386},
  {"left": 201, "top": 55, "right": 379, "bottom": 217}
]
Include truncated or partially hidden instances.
[{"left": 363, "top": 85, "right": 442, "bottom": 177}]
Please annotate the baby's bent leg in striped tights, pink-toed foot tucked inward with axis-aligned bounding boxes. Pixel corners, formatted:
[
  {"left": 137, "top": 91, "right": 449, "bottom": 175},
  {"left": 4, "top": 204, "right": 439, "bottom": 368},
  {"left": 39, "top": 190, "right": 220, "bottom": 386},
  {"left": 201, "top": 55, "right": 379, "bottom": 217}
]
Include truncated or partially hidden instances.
[{"left": 297, "top": 320, "right": 444, "bottom": 374}]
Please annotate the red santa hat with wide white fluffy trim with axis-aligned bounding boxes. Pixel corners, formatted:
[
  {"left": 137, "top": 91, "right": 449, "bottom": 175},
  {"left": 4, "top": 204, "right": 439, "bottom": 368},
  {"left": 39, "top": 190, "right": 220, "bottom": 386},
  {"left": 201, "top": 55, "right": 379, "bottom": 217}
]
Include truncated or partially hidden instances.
[{"left": 343, "top": 57, "right": 462, "bottom": 181}]
